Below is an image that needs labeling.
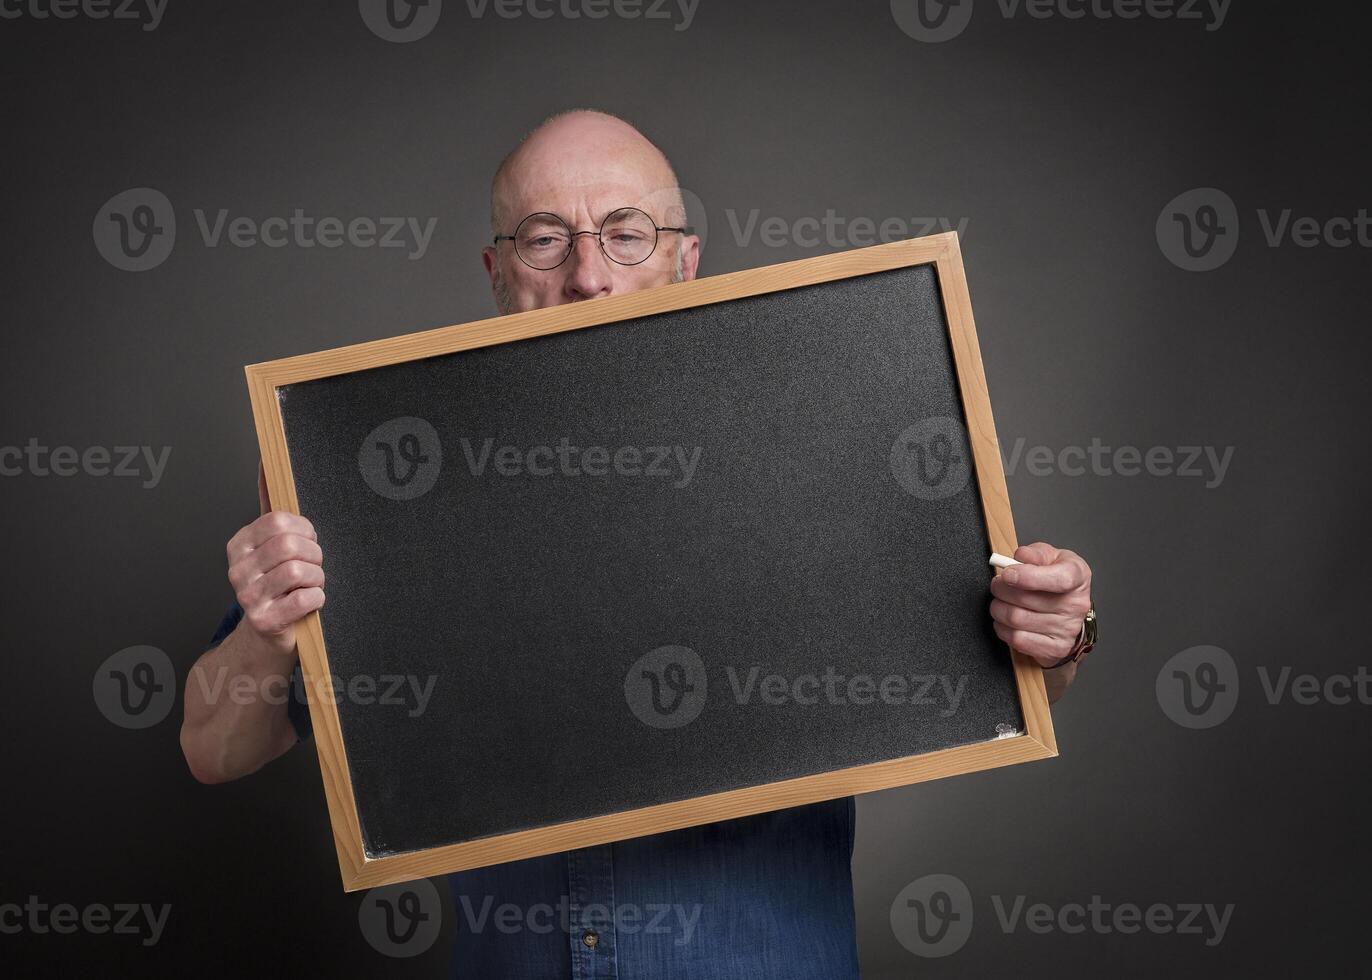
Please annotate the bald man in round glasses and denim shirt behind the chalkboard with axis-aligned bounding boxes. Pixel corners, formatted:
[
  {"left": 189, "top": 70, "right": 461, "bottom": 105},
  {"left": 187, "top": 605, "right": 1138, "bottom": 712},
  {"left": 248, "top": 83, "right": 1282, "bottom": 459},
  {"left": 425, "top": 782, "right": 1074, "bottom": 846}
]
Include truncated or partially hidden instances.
[{"left": 181, "top": 110, "right": 1091, "bottom": 980}]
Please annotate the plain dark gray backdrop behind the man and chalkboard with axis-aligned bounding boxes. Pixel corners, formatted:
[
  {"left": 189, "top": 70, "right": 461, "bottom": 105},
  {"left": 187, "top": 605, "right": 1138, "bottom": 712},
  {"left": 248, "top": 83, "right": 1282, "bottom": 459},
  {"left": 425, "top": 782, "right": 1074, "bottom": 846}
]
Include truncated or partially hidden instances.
[{"left": 0, "top": 0, "right": 1372, "bottom": 977}]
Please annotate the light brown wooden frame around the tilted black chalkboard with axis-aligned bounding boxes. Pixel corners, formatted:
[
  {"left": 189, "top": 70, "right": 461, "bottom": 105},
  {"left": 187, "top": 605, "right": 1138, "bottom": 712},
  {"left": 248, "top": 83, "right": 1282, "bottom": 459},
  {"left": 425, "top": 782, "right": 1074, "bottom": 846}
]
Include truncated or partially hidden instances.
[{"left": 246, "top": 233, "right": 1058, "bottom": 891}]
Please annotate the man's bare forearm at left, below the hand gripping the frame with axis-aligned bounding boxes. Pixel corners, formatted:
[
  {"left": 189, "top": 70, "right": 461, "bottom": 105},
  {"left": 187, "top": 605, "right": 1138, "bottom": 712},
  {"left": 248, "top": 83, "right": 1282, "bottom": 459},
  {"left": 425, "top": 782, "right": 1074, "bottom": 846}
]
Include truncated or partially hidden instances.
[{"left": 181, "top": 623, "right": 296, "bottom": 782}]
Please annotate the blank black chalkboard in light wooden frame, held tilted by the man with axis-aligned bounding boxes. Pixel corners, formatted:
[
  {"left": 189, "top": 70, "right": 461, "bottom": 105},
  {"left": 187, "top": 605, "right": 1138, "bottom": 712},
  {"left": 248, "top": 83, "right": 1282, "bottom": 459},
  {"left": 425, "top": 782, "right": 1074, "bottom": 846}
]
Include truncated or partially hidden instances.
[{"left": 246, "top": 236, "right": 1052, "bottom": 887}]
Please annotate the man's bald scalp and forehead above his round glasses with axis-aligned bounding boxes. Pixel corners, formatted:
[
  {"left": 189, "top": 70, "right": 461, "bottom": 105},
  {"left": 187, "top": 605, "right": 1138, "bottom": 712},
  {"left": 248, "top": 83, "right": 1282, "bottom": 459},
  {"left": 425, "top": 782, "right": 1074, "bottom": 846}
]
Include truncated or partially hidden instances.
[{"left": 491, "top": 108, "right": 685, "bottom": 235}]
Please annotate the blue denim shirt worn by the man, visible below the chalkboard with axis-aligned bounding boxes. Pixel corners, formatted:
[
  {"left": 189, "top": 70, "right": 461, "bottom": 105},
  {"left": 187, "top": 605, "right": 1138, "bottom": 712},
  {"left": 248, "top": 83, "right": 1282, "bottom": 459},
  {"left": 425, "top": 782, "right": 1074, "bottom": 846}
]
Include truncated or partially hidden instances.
[{"left": 211, "top": 604, "right": 859, "bottom": 980}]
